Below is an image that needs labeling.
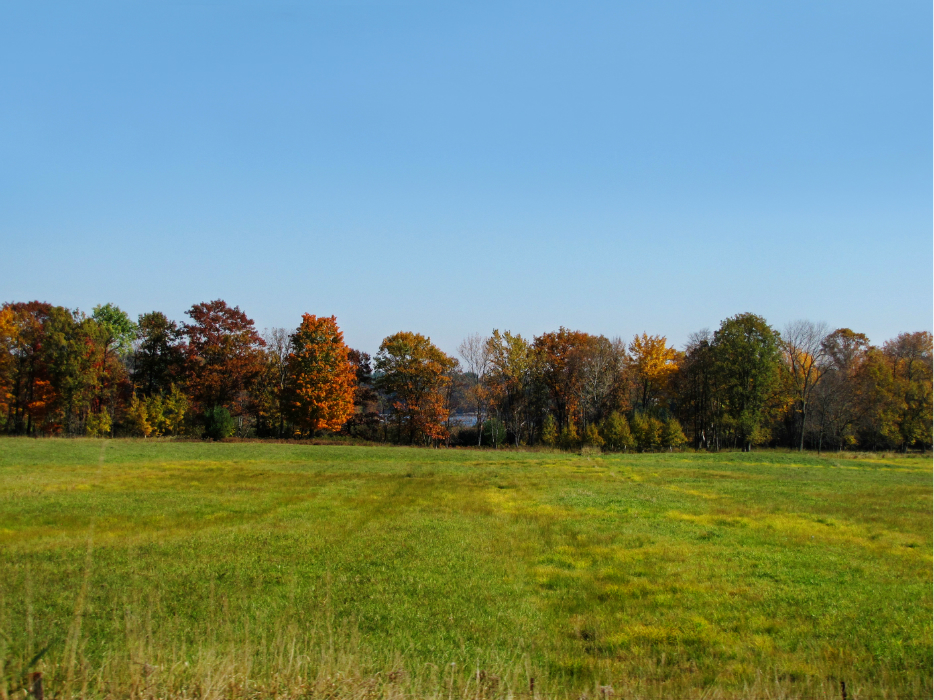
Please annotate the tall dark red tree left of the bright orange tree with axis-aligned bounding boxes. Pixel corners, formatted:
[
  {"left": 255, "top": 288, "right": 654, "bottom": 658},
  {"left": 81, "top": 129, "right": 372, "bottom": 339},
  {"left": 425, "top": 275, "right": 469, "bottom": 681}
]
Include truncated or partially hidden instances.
[{"left": 182, "top": 299, "right": 265, "bottom": 414}]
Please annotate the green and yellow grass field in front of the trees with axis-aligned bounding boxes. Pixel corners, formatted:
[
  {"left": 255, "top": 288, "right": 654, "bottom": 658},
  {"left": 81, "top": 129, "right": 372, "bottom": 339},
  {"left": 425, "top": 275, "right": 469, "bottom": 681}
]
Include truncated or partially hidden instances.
[{"left": 0, "top": 439, "right": 932, "bottom": 700}]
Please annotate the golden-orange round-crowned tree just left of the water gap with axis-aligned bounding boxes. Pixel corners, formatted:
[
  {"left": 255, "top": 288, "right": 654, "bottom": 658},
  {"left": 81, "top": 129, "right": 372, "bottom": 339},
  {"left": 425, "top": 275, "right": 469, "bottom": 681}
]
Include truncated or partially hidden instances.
[{"left": 375, "top": 332, "right": 457, "bottom": 443}]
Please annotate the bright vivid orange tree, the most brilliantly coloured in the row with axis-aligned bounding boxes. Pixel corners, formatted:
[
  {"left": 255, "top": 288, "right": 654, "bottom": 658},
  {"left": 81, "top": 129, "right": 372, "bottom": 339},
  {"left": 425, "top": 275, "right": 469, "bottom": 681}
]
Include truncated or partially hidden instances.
[{"left": 287, "top": 314, "right": 357, "bottom": 436}]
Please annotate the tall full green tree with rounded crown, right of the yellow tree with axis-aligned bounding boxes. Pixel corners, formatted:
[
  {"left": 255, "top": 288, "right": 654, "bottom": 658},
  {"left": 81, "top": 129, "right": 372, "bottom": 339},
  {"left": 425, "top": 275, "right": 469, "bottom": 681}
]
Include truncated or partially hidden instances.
[{"left": 714, "top": 313, "right": 781, "bottom": 452}]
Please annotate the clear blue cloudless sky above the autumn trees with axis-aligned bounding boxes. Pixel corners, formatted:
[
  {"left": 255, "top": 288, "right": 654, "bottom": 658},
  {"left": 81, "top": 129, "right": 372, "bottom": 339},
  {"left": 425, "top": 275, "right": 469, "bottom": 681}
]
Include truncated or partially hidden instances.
[{"left": 0, "top": 0, "right": 934, "bottom": 352}]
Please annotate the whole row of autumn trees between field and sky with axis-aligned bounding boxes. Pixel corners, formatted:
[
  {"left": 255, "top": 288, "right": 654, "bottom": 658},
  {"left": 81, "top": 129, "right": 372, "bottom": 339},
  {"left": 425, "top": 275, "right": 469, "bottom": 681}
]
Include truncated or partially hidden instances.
[{"left": 0, "top": 300, "right": 932, "bottom": 451}]
